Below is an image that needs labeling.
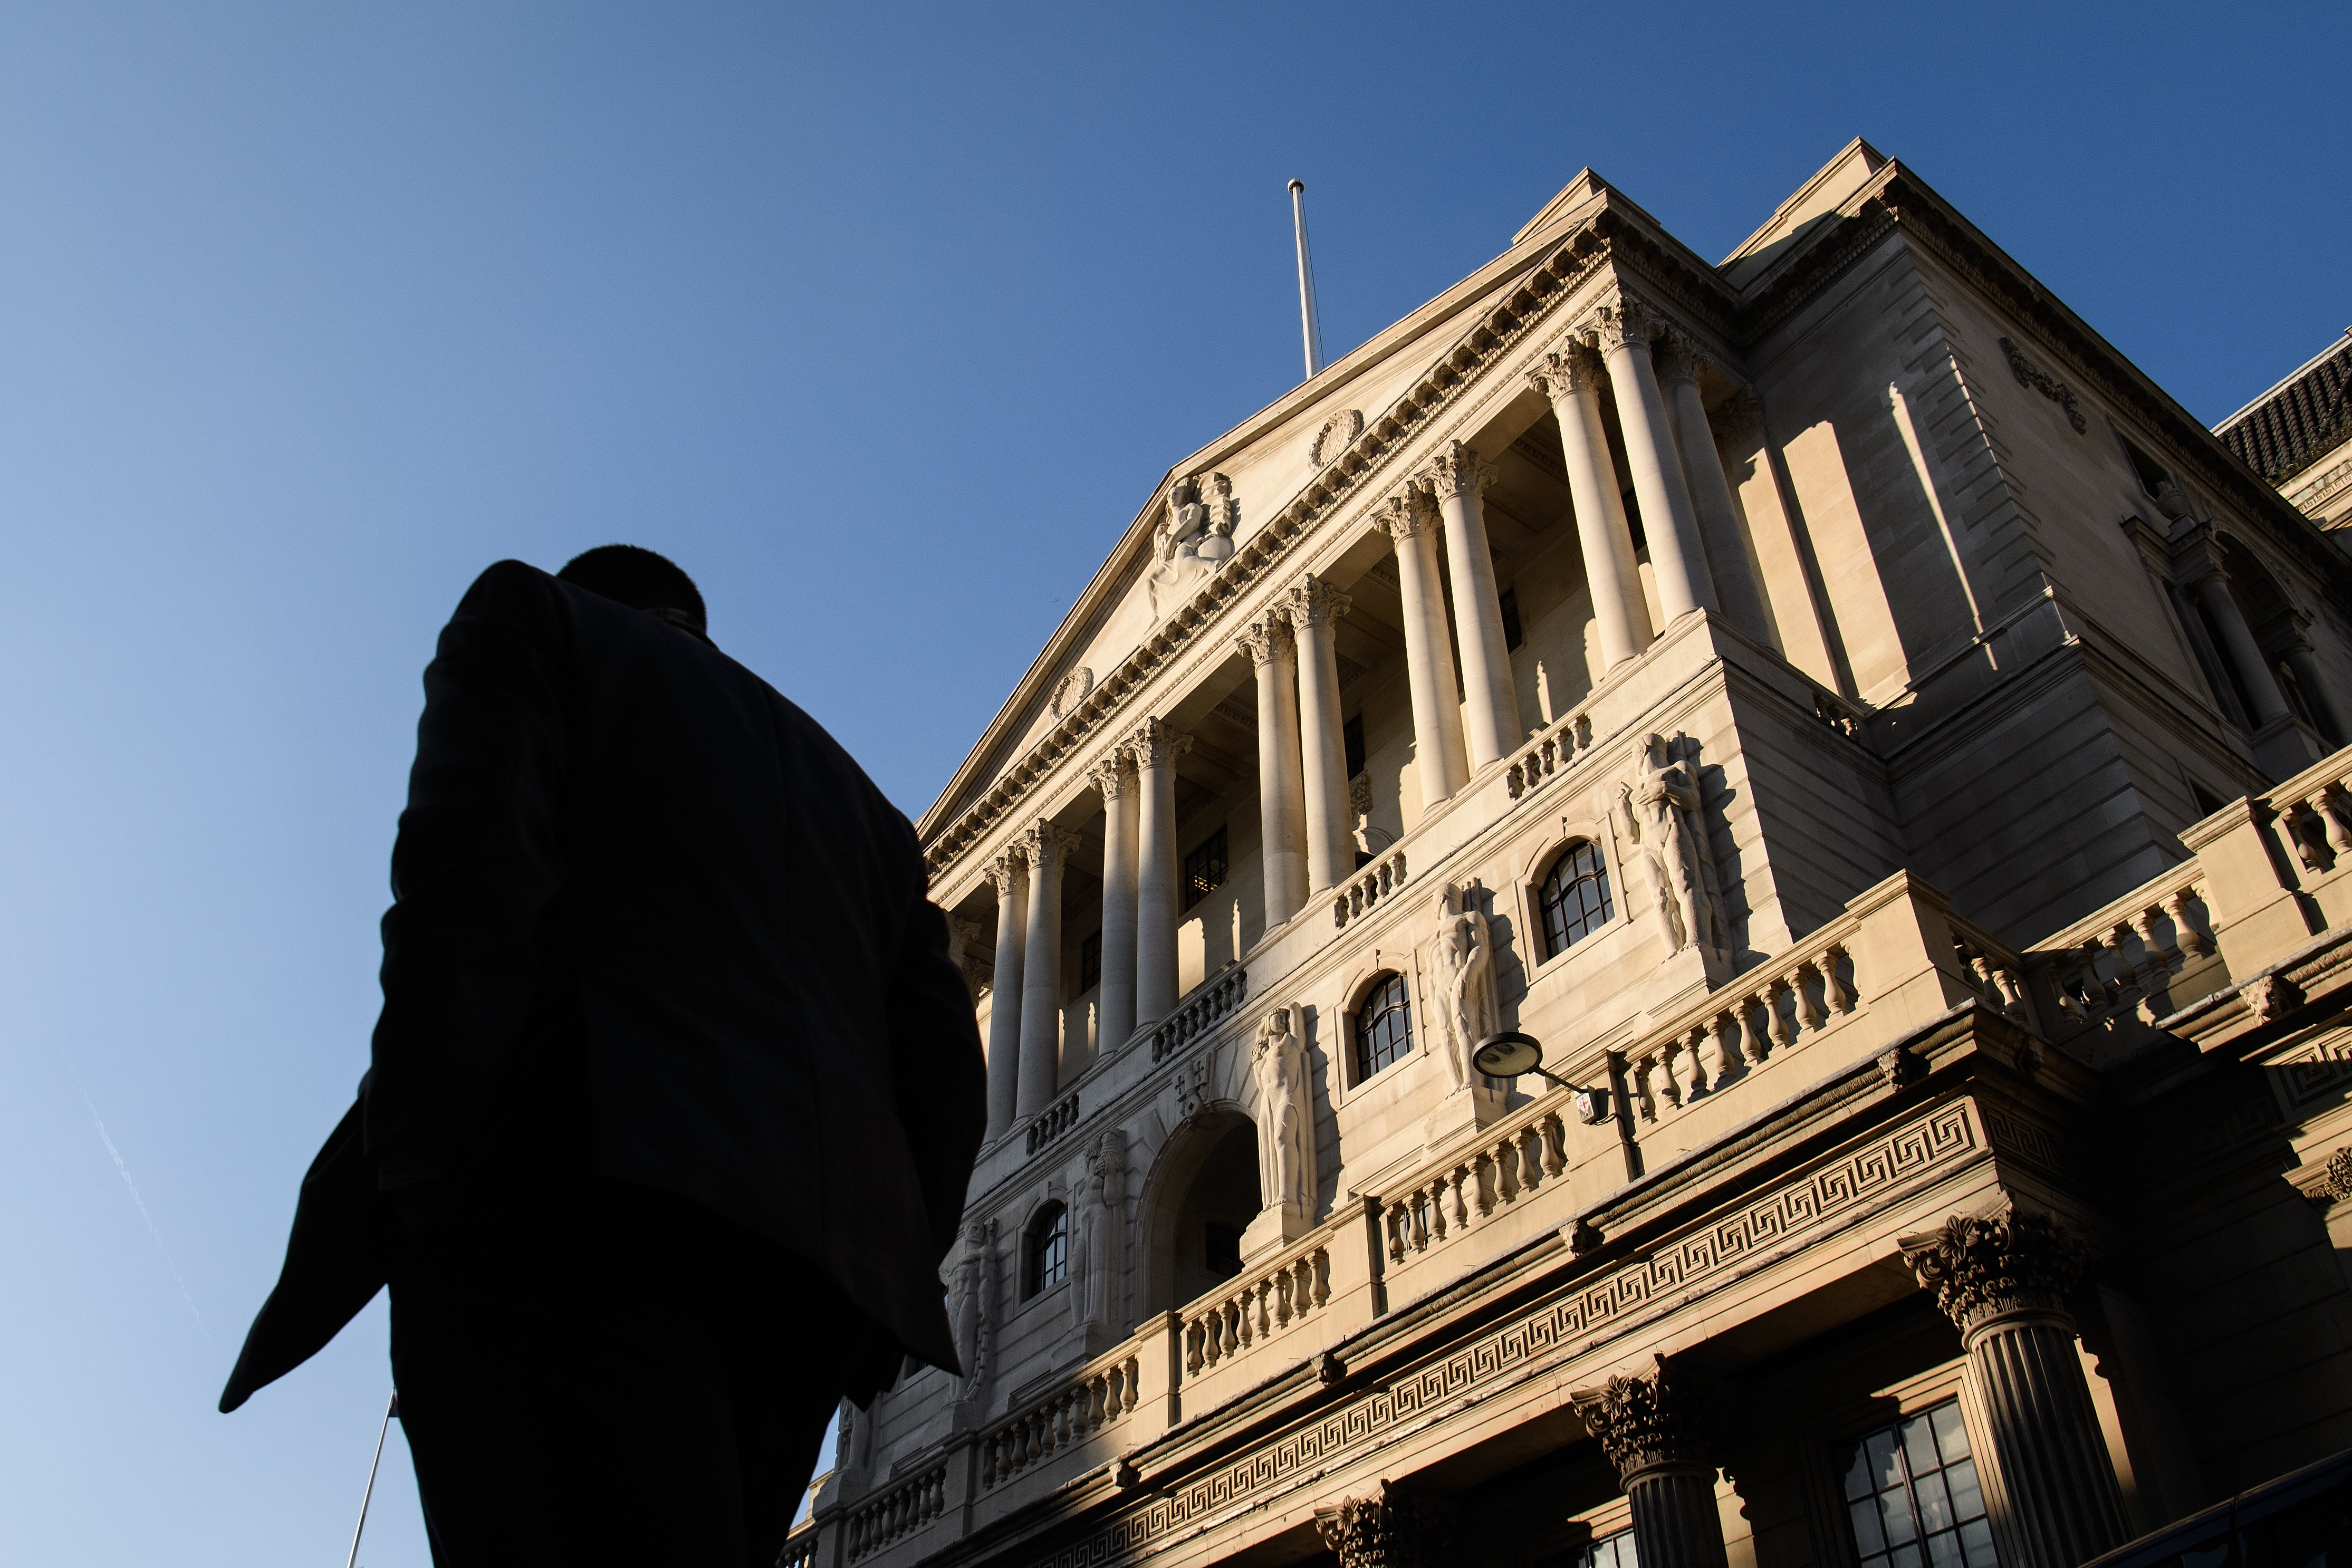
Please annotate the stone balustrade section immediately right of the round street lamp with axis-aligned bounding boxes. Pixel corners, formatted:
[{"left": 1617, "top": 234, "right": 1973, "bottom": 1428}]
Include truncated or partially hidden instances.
[{"left": 1625, "top": 940, "right": 1858, "bottom": 1121}]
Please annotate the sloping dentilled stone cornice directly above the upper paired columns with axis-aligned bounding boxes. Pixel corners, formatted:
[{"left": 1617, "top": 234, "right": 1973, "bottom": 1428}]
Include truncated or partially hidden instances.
[{"left": 924, "top": 223, "right": 1611, "bottom": 879}]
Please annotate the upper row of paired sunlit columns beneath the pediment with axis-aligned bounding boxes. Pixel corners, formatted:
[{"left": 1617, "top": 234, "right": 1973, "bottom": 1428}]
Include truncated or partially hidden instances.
[{"left": 988, "top": 296, "right": 1762, "bottom": 1138}]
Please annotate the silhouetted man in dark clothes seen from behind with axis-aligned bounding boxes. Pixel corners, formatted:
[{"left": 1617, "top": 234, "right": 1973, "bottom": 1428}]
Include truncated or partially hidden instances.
[{"left": 221, "top": 545, "right": 985, "bottom": 1568}]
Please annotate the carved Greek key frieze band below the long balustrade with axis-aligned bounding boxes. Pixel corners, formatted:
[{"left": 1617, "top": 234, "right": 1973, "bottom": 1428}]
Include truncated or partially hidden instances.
[{"left": 1033, "top": 1102, "right": 1985, "bottom": 1568}]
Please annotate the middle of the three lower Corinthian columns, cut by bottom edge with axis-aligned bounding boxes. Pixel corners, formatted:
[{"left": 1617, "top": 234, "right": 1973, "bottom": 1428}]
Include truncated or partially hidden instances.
[{"left": 1569, "top": 1357, "right": 1726, "bottom": 1568}]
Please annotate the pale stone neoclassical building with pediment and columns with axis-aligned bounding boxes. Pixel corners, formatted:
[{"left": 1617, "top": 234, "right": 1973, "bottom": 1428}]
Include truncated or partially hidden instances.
[{"left": 785, "top": 141, "right": 2352, "bottom": 1568}]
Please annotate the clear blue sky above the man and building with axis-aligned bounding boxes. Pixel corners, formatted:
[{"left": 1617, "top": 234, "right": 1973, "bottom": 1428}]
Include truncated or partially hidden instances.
[{"left": 0, "top": 0, "right": 2352, "bottom": 1568}]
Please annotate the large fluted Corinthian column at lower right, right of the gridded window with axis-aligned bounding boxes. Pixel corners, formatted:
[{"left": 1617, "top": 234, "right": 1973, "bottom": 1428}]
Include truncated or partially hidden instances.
[{"left": 1900, "top": 1208, "right": 2124, "bottom": 1568}]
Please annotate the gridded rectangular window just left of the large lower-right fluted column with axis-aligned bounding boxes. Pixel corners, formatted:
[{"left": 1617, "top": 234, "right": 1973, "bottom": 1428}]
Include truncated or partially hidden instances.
[{"left": 1837, "top": 1399, "right": 1999, "bottom": 1568}]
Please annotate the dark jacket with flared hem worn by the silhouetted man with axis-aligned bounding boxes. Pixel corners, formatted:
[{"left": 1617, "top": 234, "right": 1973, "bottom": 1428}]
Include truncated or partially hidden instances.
[{"left": 221, "top": 562, "right": 985, "bottom": 1410}]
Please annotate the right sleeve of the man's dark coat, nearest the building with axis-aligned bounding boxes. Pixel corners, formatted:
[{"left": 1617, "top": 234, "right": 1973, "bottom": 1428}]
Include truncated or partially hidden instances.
[{"left": 889, "top": 858, "right": 988, "bottom": 1258}]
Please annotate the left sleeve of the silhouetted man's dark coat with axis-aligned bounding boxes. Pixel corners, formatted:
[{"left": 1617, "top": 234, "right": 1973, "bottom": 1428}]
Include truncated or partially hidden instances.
[{"left": 367, "top": 562, "right": 567, "bottom": 1187}]
